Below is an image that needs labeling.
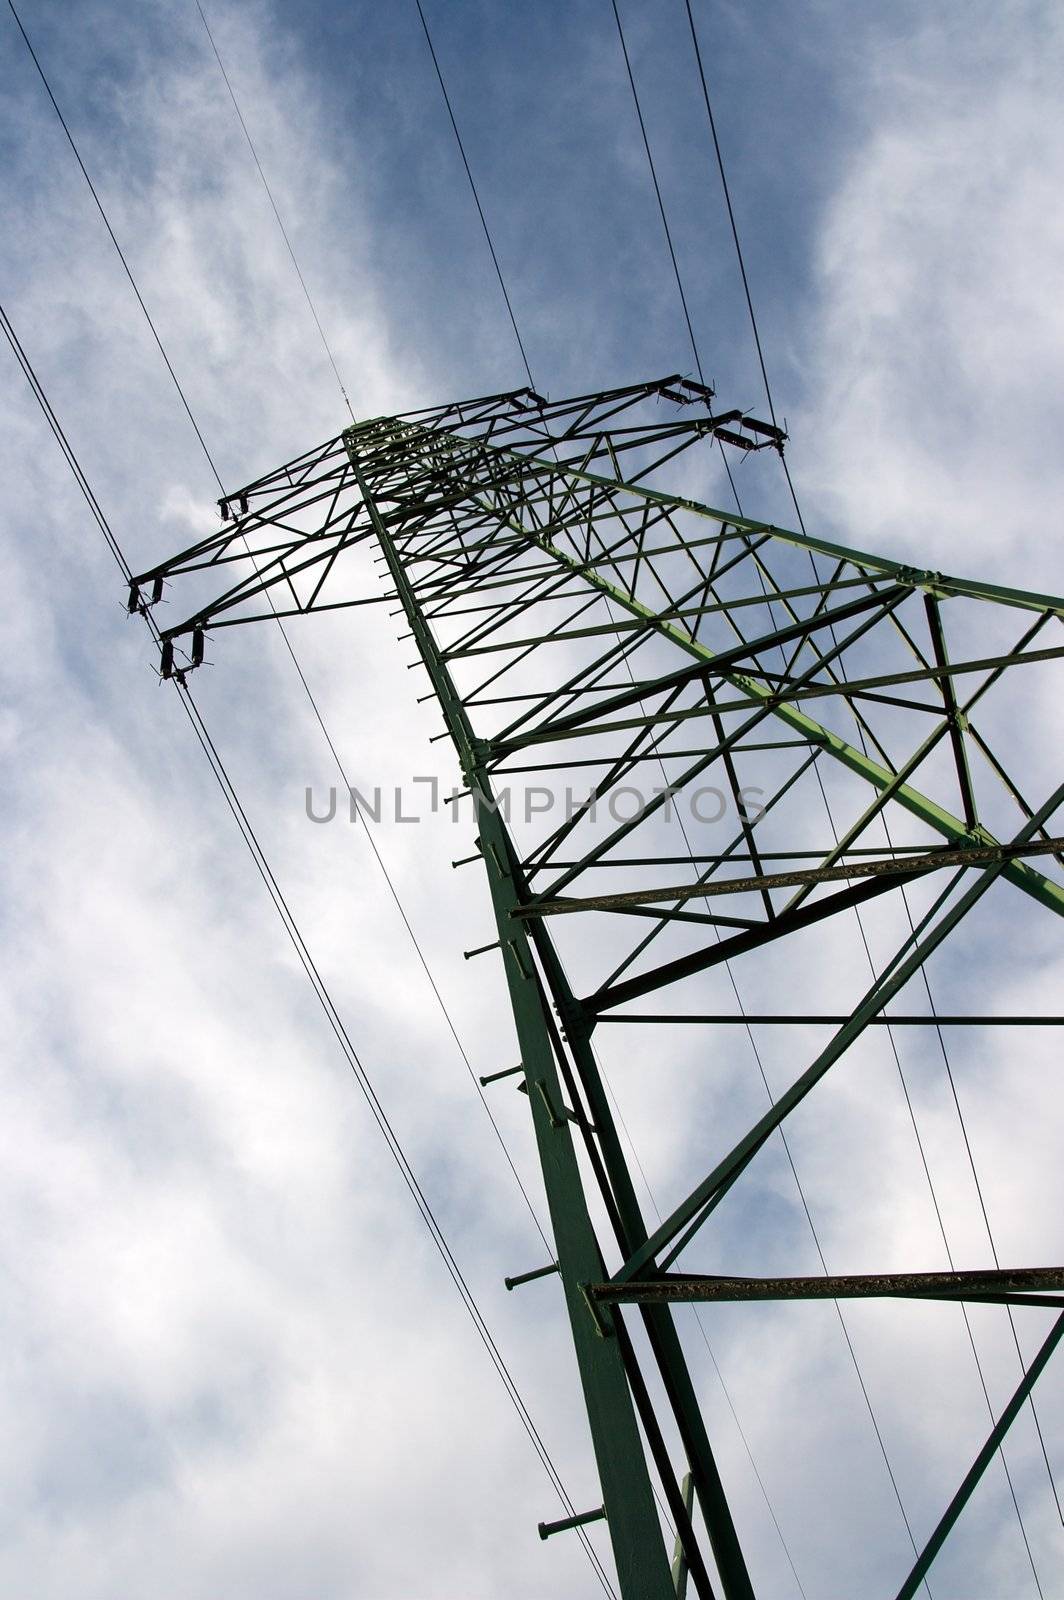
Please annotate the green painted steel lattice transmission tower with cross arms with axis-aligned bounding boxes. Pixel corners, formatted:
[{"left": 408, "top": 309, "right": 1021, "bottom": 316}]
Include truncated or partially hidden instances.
[{"left": 140, "top": 384, "right": 1064, "bottom": 1600}]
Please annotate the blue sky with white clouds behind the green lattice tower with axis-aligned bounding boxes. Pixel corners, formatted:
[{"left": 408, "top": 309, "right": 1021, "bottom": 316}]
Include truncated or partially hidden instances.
[{"left": 0, "top": 0, "right": 1064, "bottom": 1600}]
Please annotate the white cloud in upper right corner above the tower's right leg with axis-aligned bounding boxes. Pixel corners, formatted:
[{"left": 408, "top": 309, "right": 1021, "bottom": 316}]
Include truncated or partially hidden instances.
[{"left": 798, "top": 5, "right": 1064, "bottom": 590}]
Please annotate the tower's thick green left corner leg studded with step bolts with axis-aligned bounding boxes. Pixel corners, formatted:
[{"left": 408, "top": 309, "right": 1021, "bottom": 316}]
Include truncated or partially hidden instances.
[{"left": 349, "top": 442, "right": 674, "bottom": 1600}]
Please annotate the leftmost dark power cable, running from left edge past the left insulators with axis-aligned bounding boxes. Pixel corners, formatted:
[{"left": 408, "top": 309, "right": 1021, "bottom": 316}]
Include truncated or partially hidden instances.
[{"left": 0, "top": 304, "right": 616, "bottom": 1600}]
